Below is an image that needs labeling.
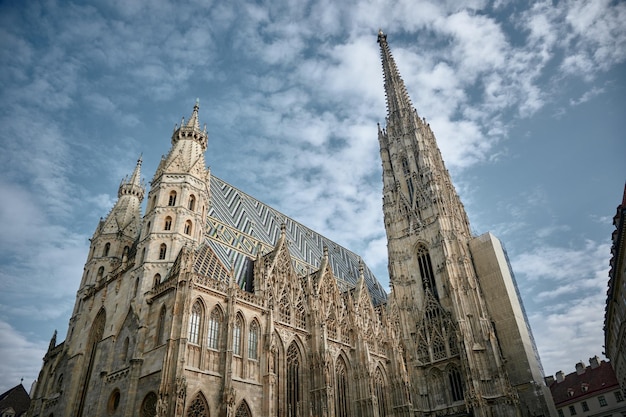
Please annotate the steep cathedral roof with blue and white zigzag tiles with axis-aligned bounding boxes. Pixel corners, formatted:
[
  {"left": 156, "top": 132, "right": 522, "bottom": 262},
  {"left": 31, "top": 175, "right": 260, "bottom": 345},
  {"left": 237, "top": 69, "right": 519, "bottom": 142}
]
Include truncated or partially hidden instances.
[{"left": 205, "top": 175, "right": 387, "bottom": 305}]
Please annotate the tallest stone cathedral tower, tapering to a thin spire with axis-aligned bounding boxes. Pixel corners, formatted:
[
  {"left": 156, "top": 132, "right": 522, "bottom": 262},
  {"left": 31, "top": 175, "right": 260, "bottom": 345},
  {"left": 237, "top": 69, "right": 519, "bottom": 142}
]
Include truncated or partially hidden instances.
[{"left": 378, "top": 31, "right": 519, "bottom": 416}]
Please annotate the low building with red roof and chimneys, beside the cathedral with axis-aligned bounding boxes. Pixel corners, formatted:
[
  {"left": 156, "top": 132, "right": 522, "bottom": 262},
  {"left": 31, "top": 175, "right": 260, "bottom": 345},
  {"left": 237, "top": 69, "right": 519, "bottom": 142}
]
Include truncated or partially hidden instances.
[{"left": 546, "top": 356, "right": 626, "bottom": 417}]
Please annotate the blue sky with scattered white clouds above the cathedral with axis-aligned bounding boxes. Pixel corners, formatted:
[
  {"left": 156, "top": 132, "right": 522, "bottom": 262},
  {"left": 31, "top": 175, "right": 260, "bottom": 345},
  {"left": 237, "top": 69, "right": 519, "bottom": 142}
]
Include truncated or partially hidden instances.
[{"left": 0, "top": 0, "right": 626, "bottom": 392}]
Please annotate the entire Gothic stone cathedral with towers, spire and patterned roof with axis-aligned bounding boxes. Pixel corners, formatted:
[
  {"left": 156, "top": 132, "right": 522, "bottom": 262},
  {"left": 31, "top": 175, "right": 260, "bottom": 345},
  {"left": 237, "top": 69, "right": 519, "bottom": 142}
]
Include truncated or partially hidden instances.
[{"left": 28, "top": 31, "right": 556, "bottom": 417}]
